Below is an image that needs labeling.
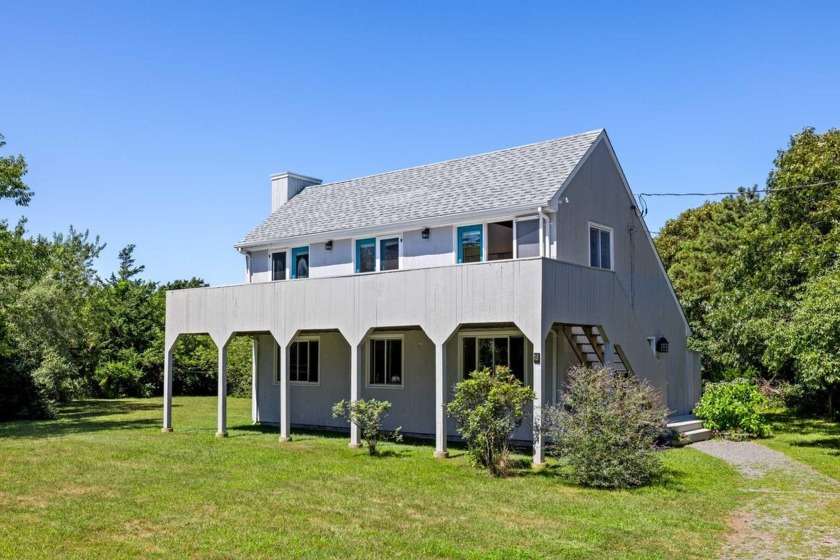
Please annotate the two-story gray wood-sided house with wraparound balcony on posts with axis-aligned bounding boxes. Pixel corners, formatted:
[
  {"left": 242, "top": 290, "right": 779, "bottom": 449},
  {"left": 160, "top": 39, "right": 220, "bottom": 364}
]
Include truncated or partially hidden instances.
[{"left": 164, "top": 130, "right": 700, "bottom": 463}]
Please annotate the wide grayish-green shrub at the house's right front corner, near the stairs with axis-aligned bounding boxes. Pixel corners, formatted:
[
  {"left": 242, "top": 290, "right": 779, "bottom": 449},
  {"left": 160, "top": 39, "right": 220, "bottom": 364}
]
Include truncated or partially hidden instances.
[{"left": 541, "top": 366, "right": 668, "bottom": 488}]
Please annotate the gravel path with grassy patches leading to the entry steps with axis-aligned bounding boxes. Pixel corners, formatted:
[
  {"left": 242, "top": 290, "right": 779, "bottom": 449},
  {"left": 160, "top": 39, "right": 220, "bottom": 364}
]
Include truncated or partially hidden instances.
[{"left": 691, "top": 440, "right": 840, "bottom": 560}]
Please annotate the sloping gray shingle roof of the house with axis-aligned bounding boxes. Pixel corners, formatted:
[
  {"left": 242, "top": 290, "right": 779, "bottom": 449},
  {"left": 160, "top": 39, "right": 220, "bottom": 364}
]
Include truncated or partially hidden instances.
[{"left": 236, "top": 130, "right": 603, "bottom": 247}]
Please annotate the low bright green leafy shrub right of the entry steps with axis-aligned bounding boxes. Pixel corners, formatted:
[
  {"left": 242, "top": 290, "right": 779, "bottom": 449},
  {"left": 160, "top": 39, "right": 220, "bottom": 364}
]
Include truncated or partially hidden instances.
[{"left": 694, "top": 379, "right": 770, "bottom": 439}]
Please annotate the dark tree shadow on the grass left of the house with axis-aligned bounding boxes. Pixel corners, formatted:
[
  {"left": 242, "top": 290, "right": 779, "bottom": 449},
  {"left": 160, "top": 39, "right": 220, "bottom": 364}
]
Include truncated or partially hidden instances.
[{"left": 0, "top": 400, "right": 166, "bottom": 439}]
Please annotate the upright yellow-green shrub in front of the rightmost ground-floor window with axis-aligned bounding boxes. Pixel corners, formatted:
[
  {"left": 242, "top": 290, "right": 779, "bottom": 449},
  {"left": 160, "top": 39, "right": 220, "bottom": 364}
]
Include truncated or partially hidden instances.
[{"left": 446, "top": 366, "right": 534, "bottom": 476}]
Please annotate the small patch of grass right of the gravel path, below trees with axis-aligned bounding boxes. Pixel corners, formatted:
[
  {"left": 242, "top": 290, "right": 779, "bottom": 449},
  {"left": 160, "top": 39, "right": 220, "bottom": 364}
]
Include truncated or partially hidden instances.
[{"left": 759, "top": 411, "right": 840, "bottom": 480}]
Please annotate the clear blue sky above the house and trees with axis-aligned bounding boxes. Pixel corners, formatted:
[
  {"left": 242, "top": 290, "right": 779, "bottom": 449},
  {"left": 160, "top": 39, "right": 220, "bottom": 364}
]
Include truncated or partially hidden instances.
[{"left": 0, "top": 0, "right": 840, "bottom": 284}]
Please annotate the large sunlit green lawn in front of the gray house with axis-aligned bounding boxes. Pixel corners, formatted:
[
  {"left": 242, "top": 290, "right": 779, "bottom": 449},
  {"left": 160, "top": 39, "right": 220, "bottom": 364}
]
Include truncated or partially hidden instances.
[{"left": 0, "top": 397, "right": 739, "bottom": 558}]
